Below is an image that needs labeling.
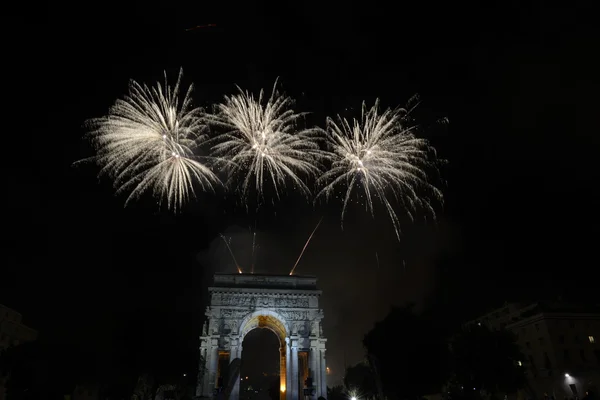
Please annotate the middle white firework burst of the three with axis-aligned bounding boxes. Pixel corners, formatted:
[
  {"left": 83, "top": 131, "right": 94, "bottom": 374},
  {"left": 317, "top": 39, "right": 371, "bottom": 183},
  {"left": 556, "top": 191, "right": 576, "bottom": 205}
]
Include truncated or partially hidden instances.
[{"left": 205, "top": 82, "right": 323, "bottom": 200}]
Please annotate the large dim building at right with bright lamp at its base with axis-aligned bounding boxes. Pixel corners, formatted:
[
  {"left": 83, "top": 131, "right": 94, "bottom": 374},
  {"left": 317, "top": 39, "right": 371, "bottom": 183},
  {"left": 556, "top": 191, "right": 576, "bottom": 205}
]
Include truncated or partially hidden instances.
[{"left": 470, "top": 303, "right": 600, "bottom": 400}]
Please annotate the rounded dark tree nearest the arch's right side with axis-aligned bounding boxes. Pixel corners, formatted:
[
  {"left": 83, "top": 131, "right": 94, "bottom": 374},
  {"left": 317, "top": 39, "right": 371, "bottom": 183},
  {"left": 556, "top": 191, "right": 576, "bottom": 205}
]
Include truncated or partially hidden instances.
[{"left": 363, "top": 305, "right": 448, "bottom": 399}]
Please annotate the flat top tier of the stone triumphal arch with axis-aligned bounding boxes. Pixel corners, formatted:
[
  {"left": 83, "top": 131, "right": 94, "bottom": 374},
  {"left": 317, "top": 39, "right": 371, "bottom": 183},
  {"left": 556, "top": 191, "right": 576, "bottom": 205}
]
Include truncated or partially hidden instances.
[{"left": 213, "top": 274, "right": 317, "bottom": 290}]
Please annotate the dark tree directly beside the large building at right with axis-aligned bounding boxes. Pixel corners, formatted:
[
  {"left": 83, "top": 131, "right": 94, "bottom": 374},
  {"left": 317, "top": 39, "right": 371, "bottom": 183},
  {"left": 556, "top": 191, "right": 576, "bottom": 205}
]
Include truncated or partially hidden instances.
[{"left": 451, "top": 325, "right": 526, "bottom": 397}]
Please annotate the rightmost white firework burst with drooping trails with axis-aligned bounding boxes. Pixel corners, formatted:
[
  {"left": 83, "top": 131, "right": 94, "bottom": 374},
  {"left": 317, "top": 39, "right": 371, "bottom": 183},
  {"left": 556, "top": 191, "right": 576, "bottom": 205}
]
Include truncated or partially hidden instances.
[{"left": 317, "top": 100, "right": 443, "bottom": 240}]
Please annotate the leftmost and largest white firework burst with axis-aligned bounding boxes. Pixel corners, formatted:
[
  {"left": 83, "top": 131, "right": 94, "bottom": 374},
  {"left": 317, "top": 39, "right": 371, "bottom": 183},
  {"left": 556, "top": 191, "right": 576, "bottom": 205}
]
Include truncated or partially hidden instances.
[{"left": 81, "top": 70, "right": 220, "bottom": 210}]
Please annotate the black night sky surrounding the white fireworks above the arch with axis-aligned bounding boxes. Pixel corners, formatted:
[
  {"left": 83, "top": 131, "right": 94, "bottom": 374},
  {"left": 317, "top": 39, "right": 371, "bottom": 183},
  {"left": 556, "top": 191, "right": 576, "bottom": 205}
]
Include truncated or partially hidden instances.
[{"left": 5, "top": 1, "right": 600, "bottom": 388}]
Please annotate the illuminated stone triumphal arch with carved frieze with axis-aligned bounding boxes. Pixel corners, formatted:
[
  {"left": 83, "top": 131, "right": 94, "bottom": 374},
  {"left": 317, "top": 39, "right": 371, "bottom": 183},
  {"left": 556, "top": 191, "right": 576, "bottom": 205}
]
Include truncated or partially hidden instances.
[{"left": 196, "top": 274, "right": 327, "bottom": 400}]
